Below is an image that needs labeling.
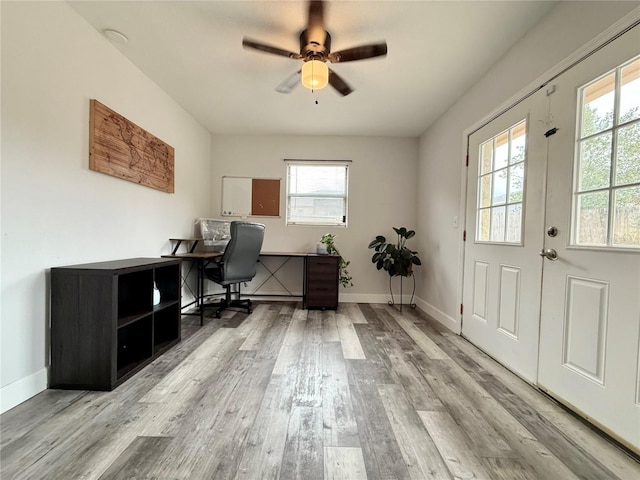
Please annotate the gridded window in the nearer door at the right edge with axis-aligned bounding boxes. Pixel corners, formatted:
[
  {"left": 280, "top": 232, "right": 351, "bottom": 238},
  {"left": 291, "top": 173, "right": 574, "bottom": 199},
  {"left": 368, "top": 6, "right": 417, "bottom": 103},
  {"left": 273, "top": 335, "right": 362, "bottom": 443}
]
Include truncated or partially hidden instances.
[{"left": 571, "top": 57, "right": 640, "bottom": 248}]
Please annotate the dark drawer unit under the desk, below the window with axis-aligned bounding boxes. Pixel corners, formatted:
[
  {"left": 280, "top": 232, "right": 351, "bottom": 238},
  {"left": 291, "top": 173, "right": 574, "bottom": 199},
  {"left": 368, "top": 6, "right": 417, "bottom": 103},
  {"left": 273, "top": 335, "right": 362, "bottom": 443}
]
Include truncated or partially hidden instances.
[{"left": 304, "top": 255, "right": 340, "bottom": 310}]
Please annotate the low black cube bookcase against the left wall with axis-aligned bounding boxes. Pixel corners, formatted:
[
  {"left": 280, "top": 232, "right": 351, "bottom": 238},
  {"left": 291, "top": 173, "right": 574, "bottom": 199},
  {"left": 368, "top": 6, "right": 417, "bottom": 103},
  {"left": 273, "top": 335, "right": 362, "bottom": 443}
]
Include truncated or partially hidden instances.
[{"left": 49, "top": 258, "right": 181, "bottom": 390}]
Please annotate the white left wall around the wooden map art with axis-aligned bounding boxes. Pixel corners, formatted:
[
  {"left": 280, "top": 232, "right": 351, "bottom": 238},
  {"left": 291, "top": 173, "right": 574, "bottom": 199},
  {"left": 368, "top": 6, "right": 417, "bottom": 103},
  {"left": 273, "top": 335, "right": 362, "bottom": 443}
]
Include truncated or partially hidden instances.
[{"left": 0, "top": 2, "right": 211, "bottom": 411}]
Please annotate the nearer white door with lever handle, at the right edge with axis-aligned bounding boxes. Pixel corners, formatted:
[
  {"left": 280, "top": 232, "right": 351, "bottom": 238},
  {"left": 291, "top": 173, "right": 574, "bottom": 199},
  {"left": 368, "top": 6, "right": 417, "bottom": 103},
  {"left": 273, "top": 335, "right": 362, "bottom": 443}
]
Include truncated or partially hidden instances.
[{"left": 538, "top": 27, "right": 640, "bottom": 451}]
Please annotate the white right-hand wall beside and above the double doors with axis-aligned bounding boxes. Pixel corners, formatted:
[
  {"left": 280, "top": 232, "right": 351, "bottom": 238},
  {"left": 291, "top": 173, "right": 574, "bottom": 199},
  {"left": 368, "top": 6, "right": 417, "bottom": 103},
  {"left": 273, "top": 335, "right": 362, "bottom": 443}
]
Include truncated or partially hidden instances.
[{"left": 417, "top": 1, "right": 637, "bottom": 330}]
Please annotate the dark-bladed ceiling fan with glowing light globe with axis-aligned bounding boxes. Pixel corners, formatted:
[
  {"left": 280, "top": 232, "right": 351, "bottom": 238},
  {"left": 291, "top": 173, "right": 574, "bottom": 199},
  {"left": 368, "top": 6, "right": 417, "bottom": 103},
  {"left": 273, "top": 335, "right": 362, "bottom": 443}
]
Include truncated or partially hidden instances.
[{"left": 242, "top": 1, "right": 387, "bottom": 96}]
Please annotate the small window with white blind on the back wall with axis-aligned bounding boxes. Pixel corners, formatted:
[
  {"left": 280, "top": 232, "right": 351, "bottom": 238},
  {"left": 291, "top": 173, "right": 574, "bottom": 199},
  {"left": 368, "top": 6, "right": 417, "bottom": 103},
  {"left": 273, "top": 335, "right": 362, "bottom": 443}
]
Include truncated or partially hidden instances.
[{"left": 287, "top": 160, "right": 349, "bottom": 226}]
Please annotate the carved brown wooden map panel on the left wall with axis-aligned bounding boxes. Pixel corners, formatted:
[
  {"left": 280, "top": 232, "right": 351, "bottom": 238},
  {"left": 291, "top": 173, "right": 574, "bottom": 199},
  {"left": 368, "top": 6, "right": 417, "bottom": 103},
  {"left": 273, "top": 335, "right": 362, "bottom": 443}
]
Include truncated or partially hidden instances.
[{"left": 89, "top": 100, "right": 175, "bottom": 193}]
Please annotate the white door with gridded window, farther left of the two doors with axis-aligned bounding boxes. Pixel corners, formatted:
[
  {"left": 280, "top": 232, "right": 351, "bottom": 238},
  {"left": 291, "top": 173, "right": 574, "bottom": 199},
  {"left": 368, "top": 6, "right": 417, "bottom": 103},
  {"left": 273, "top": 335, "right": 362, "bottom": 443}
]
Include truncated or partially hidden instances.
[{"left": 462, "top": 91, "right": 548, "bottom": 382}]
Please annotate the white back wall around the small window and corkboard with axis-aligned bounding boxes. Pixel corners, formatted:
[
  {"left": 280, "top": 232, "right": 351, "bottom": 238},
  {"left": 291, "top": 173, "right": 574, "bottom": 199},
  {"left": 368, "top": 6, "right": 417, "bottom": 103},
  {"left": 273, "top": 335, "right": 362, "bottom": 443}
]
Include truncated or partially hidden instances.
[{"left": 211, "top": 135, "right": 420, "bottom": 302}]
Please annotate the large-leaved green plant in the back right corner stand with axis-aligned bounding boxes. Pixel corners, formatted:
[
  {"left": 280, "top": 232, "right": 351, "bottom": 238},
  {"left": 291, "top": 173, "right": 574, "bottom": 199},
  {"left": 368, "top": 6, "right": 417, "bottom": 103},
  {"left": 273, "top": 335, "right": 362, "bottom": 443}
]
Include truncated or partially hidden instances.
[{"left": 369, "top": 227, "right": 422, "bottom": 277}]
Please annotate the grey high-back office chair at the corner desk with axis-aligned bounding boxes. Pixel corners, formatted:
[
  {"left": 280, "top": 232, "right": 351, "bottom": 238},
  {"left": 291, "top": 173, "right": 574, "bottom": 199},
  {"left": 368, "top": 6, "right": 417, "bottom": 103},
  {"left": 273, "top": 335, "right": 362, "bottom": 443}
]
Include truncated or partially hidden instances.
[{"left": 204, "top": 222, "right": 264, "bottom": 318}]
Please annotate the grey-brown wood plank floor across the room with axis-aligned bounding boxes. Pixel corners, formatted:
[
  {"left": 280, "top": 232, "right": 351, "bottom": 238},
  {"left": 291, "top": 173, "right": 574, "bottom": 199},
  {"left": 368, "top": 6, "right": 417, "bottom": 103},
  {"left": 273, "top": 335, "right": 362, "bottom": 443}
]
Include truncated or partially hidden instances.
[{"left": 0, "top": 302, "right": 640, "bottom": 480}]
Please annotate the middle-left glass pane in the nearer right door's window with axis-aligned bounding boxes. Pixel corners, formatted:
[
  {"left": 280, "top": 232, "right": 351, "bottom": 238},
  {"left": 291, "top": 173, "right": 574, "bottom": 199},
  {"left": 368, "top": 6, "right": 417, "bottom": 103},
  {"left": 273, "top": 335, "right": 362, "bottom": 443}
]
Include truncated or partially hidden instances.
[{"left": 578, "top": 132, "right": 611, "bottom": 192}]
